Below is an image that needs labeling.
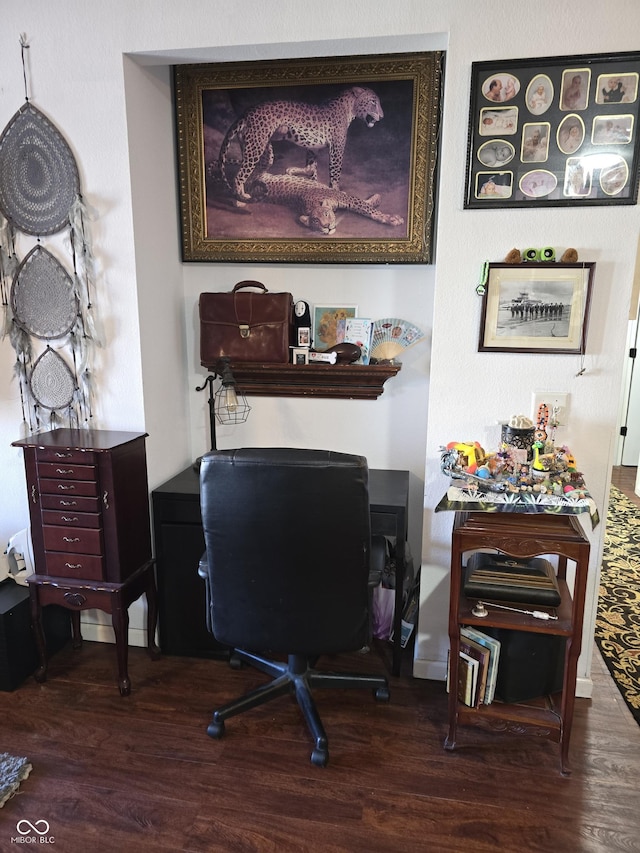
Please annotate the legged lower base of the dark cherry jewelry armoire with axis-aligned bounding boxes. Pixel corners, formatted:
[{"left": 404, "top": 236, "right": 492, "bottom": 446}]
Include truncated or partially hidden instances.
[{"left": 28, "top": 560, "right": 160, "bottom": 696}]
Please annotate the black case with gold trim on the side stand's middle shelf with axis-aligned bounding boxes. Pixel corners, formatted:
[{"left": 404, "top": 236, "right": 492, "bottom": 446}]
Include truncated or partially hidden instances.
[{"left": 464, "top": 551, "right": 560, "bottom": 607}]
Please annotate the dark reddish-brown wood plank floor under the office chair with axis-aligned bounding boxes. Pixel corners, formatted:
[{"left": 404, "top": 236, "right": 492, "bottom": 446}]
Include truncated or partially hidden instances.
[{"left": 0, "top": 480, "right": 640, "bottom": 853}]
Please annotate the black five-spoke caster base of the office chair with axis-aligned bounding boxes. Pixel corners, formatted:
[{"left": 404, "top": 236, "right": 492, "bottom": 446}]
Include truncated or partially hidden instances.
[{"left": 207, "top": 649, "right": 389, "bottom": 767}]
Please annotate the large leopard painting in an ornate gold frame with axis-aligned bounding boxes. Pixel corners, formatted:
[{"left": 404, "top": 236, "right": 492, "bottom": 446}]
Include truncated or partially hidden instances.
[{"left": 174, "top": 51, "right": 443, "bottom": 264}]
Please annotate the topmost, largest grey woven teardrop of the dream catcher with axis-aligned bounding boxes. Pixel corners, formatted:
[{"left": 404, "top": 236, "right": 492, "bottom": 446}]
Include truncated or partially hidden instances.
[{"left": 0, "top": 102, "right": 80, "bottom": 235}]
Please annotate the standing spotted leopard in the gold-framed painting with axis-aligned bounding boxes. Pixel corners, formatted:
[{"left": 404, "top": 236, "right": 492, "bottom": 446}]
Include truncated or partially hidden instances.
[{"left": 217, "top": 86, "right": 384, "bottom": 201}]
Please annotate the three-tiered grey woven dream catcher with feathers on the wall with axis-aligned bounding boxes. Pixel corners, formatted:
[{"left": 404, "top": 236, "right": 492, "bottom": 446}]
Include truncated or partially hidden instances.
[{"left": 0, "top": 37, "right": 100, "bottom": 432}]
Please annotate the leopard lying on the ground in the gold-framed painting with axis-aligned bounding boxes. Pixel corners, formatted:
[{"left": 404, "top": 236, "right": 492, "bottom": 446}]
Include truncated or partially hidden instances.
[{"left": 249, "top": 158, "right": 404, "bottom": 236}]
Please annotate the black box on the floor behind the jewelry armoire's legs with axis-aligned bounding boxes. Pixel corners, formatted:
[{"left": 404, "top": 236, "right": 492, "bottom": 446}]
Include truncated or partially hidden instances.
[{"left": 0, "top": 578, "right": 71, "bottom": 691}]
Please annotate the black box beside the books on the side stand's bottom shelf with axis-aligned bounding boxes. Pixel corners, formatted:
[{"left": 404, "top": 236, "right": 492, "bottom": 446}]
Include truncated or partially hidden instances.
[{"left": 483, "top": 627, "right": 566, "bottom": 702}]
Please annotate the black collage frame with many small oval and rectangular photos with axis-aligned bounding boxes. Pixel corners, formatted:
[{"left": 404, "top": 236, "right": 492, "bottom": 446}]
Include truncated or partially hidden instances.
[{"left": 464, "top": 52, "right": 640, "bottom": 209}]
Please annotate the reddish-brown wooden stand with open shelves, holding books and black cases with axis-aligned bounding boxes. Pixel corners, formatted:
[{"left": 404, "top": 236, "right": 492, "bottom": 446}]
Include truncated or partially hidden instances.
[{"left": 445, "top": 512, "right": 590, "bottom": 775}]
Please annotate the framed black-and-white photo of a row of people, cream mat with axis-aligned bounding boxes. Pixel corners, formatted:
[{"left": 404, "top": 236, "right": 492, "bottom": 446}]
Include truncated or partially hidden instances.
[{"left": 478, "top": 262, "right": 596, "bottom": 354}]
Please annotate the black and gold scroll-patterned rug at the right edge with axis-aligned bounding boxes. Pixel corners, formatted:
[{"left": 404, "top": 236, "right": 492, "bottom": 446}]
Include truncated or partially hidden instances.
[{"left": 595, "top": 486, "right": 640, "bottom": 725}]
